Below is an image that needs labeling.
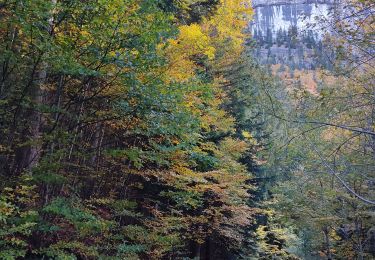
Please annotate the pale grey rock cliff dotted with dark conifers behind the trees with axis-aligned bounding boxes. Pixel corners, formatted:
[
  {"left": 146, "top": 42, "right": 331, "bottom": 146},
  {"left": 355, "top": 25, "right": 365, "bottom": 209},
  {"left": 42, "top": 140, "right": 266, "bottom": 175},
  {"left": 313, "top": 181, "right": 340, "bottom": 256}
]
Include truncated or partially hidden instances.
[{"left": 250, "top": 0, "right": 338, "bottom": 69}]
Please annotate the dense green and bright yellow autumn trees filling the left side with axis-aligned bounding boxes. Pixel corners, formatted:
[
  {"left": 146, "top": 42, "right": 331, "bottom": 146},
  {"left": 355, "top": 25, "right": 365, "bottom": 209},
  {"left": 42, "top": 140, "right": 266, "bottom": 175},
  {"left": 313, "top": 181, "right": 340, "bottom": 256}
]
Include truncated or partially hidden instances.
[{"left": 0, "top": 0, "right": 255, "bottom": 259}]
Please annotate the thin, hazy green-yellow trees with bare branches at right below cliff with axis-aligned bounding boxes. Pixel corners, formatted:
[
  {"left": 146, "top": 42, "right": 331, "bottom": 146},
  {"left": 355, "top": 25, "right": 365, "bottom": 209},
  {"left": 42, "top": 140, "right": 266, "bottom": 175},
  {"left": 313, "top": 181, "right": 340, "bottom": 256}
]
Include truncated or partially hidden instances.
[{"left": 264, "top": 1, "right": 375, "bottom": 259}]
